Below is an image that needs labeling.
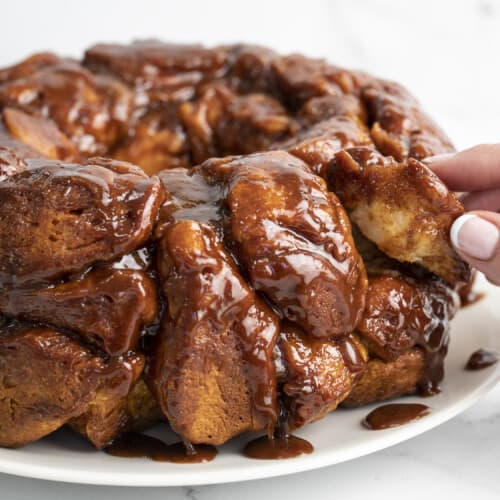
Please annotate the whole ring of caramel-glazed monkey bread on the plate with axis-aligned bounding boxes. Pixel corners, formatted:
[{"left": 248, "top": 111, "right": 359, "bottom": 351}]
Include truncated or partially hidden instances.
[{"left": 0, "top": 40, "right": 469, "bottom": 448}]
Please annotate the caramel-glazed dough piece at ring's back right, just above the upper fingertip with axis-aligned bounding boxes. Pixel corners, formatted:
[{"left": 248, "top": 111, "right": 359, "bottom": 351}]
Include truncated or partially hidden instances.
[{"left": 361, "top": 79, "right": 454, "bottom": 161}]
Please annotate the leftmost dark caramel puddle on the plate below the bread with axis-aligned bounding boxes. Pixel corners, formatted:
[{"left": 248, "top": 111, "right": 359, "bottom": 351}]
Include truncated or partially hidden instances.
[{"left": 104, "top": 432, "right": 217, "bottom": 464}]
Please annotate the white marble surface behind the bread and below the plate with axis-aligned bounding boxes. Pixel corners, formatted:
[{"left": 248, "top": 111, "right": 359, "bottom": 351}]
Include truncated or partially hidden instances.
[{"left": 0, "top": 0, "right": 500, "bottom": 500}]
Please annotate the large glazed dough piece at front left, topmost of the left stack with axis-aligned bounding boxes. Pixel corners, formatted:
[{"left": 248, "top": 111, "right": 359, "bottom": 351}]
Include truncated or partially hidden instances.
[{"left": 0, "top": 158, "right": 162, "bottom": 285}]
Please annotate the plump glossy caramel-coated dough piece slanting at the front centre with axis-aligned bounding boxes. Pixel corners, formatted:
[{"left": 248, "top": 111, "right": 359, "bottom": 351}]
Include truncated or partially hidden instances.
[{"left": 200, "top": 151, "right": 366, "bottom": 338}]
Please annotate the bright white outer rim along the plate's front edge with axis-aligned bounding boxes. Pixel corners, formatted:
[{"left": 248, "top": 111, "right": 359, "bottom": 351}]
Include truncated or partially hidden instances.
[{"left": 0, "top": 282, "right": 500, "bottom": 487}]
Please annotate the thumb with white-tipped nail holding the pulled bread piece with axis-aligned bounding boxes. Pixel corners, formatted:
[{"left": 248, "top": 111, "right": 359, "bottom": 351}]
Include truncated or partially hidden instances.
[{"left": 450, "top": 211, "right": 500, "bottom": 285}]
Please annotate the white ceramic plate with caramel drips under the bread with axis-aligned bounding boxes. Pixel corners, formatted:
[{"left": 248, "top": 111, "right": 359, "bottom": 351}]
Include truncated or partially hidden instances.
[{"left": 0, "top": 279, "right": 500, "bottom": 486}]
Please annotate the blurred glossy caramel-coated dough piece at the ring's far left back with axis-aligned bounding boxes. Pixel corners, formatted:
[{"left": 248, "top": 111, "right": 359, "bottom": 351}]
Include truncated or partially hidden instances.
[{"left": 0, "top": 58, "right": 132, "bottom": 155}]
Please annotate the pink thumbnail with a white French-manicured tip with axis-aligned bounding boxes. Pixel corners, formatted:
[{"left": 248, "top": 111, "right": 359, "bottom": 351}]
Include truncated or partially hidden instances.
[{"left": 450, "top": 214, "right": 499, "bottom": 260}]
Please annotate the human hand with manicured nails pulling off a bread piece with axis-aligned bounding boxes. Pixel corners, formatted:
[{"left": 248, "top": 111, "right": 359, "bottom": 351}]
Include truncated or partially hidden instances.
[{"left": 425, "top": 144, "right": 500, "bottom": 285}]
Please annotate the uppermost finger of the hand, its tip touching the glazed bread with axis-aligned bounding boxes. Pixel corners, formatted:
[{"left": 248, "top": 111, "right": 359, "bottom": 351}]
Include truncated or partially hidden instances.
[{"left": 424, "top": 144, "right": 500, "bottom": 192}]
